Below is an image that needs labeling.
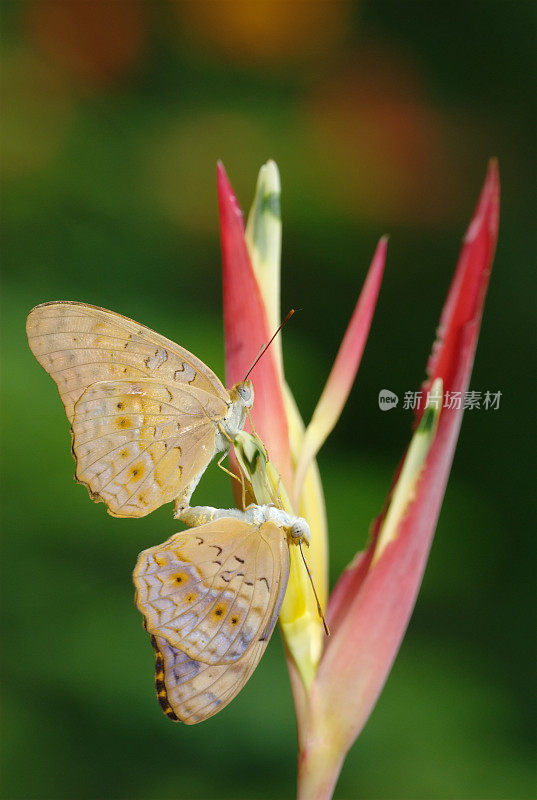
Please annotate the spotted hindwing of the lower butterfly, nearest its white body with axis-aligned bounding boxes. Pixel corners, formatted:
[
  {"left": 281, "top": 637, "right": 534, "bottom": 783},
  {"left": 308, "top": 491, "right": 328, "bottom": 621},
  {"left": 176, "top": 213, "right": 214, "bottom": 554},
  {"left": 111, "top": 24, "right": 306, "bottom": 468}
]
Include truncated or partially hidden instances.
[{"left": 133, "top": 517, "right": 289, "bottom": 665}]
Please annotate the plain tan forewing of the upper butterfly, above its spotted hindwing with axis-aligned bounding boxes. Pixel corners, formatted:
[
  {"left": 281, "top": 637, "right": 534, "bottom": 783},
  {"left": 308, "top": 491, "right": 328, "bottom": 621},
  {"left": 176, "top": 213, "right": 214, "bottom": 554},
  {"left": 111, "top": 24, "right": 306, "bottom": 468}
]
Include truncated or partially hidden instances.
[{"left": 26, "top": 302, "right": 229, "bottom": 422}]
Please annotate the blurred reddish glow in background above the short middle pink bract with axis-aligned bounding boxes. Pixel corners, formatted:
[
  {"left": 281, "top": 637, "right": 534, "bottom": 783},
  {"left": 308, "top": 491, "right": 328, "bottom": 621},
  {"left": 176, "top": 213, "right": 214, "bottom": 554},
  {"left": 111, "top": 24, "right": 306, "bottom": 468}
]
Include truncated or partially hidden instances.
[{"left": 305, "top": 41, "right": 460, "bottom": 225}]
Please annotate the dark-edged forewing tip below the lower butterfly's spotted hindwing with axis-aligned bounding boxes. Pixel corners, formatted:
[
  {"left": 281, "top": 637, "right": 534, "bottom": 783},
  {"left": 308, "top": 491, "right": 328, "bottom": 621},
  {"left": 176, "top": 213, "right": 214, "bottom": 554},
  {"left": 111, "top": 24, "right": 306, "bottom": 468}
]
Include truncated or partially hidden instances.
[{"left": 151, "top": 636, "right": 268, "bottom": 725}]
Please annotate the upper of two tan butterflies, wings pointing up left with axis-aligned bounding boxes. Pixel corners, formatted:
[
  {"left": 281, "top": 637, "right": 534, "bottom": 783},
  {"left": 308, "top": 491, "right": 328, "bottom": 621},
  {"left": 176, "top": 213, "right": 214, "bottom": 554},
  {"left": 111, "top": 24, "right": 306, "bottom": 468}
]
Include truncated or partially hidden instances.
[{"left": 26, "top": 301, "right": 254, "bottom": 517}]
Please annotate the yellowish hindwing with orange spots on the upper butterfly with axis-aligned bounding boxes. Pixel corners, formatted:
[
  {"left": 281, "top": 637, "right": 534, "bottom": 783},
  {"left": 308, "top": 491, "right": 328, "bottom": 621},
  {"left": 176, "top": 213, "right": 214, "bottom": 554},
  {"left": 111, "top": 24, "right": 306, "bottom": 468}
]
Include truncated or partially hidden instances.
[{"left": 72, "top": 378, "right": 227, "bottom": 517}]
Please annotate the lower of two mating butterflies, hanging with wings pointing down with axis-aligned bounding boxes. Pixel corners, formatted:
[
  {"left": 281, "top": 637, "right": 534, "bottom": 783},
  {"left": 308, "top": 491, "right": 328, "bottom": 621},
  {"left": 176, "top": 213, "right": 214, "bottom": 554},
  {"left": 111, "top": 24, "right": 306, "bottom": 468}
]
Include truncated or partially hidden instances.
[{"left": 133, "top": 506, "right": 310, "bottom": 725}]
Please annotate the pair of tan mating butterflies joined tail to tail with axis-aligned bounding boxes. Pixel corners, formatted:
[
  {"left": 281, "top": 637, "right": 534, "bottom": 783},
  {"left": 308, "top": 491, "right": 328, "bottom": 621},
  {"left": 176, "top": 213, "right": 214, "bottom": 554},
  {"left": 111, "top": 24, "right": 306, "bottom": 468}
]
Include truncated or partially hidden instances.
[{"left": 26, "top": 302, "right": 308, "bottom": 724}]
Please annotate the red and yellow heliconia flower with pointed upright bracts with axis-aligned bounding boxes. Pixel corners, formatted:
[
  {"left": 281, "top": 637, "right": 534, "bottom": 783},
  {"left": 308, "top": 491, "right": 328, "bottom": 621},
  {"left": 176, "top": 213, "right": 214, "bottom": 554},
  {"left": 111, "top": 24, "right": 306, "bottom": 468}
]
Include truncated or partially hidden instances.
[{"left": 218, "top": 161, "right": 500, "bottom": 800}]
